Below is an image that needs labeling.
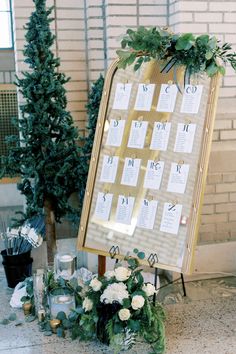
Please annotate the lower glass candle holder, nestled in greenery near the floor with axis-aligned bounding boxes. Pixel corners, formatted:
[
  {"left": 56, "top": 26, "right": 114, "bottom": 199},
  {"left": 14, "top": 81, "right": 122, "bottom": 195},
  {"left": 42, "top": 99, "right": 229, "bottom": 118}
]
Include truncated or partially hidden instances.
[{"left": 49, "top": 290, "right": 75, "bottom": 318}]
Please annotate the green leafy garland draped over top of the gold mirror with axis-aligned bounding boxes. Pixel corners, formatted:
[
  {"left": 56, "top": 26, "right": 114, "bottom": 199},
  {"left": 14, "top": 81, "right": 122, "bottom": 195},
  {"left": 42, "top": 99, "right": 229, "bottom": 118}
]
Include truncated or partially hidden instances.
[{"left": 117, "top": 27, "right": 236, "bottom": 77}]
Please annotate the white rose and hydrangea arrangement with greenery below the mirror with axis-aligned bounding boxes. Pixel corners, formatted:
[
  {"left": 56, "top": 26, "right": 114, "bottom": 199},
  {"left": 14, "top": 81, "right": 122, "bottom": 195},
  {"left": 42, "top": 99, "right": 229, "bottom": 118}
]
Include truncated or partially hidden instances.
[{"left": 78, "top": 258, "right": 165, "bottom": 353}]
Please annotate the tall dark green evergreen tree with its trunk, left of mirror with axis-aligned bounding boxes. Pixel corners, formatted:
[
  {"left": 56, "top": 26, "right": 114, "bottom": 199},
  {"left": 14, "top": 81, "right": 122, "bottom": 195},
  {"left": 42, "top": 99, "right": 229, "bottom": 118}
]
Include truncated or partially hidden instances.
[{"left": 1, "top": 0, "right": 87, "bottom": 264}]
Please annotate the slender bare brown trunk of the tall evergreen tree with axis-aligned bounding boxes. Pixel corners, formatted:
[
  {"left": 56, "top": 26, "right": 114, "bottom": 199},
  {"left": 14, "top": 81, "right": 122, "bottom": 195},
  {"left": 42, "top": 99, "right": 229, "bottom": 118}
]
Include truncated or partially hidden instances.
[{"left": 44, "top": 198, "right": 57, "bottom": 267}]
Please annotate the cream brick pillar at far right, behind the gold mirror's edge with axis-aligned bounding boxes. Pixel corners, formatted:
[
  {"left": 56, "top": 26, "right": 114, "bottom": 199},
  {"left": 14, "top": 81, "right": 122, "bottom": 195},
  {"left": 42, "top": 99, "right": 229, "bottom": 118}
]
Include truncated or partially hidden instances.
[{"left": 169, "top": 0, "right": 236, "bottom": 243}]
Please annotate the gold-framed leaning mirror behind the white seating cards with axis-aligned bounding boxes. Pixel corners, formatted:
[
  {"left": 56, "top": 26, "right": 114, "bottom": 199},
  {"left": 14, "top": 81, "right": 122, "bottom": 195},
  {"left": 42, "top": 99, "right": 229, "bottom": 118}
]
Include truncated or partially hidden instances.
[{"left": 78, "top": 60, "right": 220, "bottom": 274}]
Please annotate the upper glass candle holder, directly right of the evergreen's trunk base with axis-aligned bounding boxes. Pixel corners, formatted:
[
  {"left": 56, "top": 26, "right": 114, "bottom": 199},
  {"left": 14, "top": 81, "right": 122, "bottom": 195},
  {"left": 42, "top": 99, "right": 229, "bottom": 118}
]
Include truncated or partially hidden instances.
[{"left": 54, "top": 253, "right": 77, "bottom": 280}]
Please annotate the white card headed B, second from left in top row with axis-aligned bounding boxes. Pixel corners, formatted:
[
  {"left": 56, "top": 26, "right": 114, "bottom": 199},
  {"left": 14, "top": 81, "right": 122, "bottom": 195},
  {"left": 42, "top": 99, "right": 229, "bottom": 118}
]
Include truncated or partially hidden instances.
[{"left": 134, "top": 84, "right": 155, "bottom": 111}]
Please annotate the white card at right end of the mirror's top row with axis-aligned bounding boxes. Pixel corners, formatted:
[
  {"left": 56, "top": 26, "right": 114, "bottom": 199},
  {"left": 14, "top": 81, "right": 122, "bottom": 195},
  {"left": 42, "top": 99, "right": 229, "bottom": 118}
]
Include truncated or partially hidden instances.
[{"left": 180, "top": 85, "right": 203, "bottom": 114}]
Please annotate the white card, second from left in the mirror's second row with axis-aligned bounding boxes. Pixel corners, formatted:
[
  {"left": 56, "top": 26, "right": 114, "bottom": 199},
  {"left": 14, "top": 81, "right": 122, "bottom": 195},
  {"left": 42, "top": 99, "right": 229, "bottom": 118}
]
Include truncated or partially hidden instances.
[{"left": 127, "top": 120, "right": 148, "bottom": 149}]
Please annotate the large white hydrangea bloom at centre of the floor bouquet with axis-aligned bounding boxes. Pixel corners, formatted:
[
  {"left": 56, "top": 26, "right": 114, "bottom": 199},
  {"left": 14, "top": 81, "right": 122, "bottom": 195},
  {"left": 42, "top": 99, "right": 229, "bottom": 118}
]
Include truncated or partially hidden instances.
[{"left": 100, "top": 283, "right": 129, "bottom": 305}]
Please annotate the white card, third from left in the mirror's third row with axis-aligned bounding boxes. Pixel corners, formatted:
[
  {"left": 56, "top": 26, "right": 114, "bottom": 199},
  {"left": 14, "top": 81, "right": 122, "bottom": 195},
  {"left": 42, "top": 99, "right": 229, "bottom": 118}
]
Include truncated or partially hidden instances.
[{"left": 143, "top": 160, "right": 165, "bottom": 189}]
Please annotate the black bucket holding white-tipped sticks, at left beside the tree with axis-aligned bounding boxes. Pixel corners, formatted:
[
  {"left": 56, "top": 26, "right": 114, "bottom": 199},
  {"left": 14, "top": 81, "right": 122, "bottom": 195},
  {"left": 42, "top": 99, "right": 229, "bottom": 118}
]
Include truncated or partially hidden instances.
[{"left": 1, "top": 250, "right": 33, "bottom": 288}]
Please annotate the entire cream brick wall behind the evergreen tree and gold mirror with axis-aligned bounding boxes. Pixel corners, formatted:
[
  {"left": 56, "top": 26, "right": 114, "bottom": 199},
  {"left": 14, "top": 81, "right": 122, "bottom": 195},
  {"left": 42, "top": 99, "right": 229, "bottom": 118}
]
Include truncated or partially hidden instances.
[{"left": 13, "top": 0, "right": 236, "bottom": 248}]
